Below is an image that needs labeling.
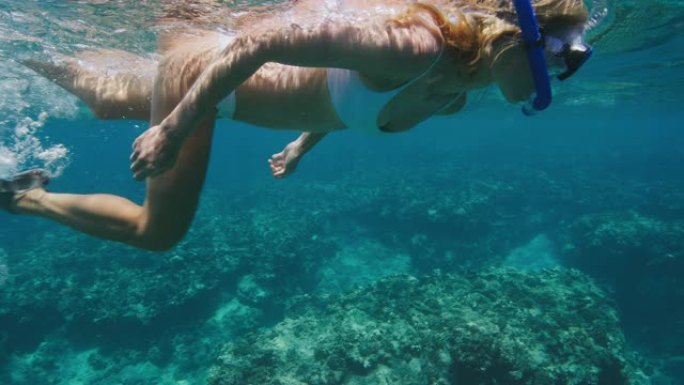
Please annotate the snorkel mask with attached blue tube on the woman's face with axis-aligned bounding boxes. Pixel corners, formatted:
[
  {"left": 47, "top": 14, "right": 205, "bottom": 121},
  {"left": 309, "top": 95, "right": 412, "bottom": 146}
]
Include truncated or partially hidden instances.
[{"left": 513, "top": 0, "right": 592, "bottom": 116}]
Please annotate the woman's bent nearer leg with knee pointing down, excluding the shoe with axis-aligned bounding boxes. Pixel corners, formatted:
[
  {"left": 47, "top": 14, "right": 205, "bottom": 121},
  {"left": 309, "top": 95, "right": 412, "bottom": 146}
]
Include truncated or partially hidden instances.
[{"left": 12, "top": 48, "right": 214, "bottom": 250}]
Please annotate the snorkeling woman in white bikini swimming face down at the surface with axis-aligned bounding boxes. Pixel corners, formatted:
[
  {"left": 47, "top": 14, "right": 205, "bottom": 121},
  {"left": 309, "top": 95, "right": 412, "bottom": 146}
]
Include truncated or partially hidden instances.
[{"left": 0, "top": 0, "right": 587, "bottom": 250}]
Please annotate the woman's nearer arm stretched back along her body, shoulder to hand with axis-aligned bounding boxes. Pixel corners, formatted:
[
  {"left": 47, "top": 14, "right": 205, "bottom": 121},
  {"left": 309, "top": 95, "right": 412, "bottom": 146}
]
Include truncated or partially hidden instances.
[{"left": 131, "top": 16, "right": 442, "bottom": 180}]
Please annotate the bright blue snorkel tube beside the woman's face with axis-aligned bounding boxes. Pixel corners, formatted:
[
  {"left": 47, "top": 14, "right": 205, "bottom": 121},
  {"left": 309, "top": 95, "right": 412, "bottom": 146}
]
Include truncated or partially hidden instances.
[{"left": 513, "top": 0, "right": 551, "bottom": 116}]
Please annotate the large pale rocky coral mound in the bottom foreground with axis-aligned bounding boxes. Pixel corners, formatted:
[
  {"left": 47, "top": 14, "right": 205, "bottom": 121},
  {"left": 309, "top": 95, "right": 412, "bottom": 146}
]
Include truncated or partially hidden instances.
[{"left": 209, "top": 269, "right": 647, "bottom": 385}]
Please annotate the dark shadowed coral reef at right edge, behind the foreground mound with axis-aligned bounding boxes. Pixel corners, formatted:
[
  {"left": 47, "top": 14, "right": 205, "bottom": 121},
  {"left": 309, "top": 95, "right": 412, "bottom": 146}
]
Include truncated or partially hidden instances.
[{"left": 564, "top": 211, "right": 684, "bottom": 355}]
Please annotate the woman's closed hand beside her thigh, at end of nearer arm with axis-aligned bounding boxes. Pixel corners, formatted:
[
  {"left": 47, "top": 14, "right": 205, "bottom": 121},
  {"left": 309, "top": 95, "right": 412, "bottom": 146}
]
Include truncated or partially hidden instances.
[{"left": 131, "top": 125, "right": 181, "bottom": 180}]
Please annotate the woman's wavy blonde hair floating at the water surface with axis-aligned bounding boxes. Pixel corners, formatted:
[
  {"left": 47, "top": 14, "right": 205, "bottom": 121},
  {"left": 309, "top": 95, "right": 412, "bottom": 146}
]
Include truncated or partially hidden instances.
[{"left": 395, "top": 0, "right": 588, "bottom": 75}]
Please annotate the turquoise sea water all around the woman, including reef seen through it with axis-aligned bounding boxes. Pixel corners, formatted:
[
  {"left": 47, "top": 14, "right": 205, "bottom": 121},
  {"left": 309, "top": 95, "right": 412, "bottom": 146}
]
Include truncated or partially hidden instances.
[{"left": 0, "top": 0, "right": 684, "bottom": 385}]
